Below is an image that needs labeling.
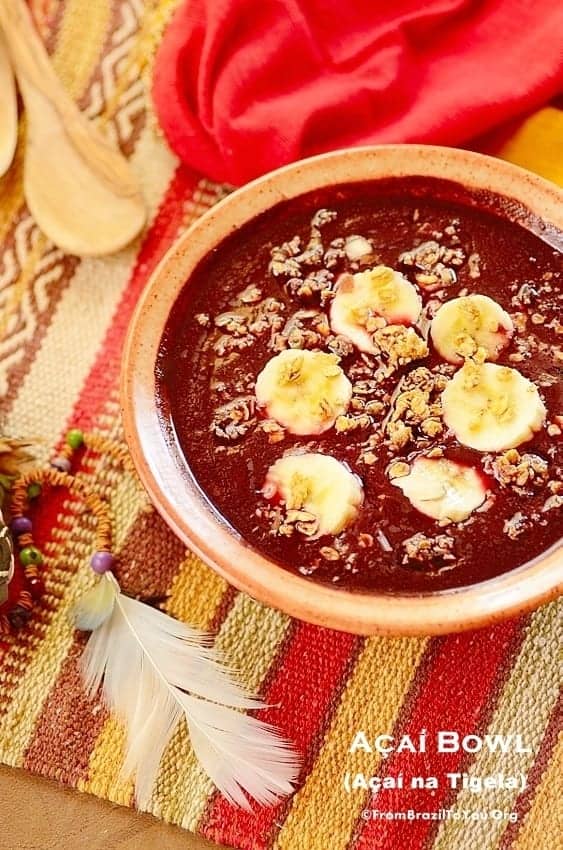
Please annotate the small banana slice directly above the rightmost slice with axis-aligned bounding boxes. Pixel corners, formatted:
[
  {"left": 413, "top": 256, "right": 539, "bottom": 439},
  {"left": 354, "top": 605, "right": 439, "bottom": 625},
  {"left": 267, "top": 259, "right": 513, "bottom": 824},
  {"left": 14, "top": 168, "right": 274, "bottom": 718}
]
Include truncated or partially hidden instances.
[{"left": 430, "top": 295, "right": 514, "bottom": 363}]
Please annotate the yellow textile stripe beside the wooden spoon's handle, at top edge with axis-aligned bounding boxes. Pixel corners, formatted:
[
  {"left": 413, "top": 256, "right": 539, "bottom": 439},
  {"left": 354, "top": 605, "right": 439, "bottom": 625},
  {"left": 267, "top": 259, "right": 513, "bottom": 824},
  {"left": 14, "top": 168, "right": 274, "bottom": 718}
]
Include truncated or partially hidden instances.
[{"left": 53, "top": 0, "right": 112, "bottom": 100}]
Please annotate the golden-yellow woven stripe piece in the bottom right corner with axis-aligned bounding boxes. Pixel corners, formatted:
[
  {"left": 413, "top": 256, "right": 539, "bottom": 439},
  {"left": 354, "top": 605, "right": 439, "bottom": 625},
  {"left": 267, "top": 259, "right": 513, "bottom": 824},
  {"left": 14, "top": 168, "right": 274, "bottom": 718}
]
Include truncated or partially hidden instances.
[{"left": 513, "top": 732, "right": 563, "bottom": 850}]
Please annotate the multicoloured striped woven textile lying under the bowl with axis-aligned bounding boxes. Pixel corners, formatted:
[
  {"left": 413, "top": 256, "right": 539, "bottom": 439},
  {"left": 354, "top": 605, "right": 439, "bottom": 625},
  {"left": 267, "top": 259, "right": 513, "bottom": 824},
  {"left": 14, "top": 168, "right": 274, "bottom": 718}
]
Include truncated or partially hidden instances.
[{"left": 0, "top": 0, "right": 563, "bottom": 850}]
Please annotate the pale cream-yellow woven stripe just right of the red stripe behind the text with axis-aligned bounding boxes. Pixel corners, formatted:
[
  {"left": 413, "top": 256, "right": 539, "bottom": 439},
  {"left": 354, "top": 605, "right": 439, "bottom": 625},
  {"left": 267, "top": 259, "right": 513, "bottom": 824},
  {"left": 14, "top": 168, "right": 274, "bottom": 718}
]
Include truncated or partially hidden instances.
[{"left": 433, "top": 602, "right": 563, "bottom": 850}]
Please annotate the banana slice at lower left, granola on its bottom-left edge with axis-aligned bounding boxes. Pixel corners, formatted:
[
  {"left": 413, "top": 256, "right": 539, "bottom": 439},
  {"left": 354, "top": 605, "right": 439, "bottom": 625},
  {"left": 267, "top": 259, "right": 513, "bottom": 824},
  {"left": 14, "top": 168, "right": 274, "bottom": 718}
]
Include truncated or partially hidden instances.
[{"left": 262, "top": 452, "right": 364, "bottom": 540}]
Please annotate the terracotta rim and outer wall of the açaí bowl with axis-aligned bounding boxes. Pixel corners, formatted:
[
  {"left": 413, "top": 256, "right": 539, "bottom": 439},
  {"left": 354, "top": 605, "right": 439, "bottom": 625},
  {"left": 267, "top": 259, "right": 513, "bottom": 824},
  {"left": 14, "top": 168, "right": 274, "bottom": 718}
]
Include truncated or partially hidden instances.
[{"left": 122, "top": 145, "right": 563, "bottom": 635}]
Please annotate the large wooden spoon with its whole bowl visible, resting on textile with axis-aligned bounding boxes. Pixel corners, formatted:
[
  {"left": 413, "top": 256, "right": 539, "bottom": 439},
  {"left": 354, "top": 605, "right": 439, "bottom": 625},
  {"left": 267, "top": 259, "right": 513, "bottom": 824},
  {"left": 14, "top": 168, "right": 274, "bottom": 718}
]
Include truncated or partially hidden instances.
[{"left": 0, "top": 0, "right": 146, "bottom": 256}]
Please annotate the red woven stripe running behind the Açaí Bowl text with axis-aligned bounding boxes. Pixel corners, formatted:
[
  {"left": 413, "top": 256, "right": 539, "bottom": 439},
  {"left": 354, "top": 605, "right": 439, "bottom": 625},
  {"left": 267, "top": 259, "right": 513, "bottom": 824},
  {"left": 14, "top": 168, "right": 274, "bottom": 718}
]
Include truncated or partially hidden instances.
[{"left": 354, "top": 620, "right": 522, "bottom": 850}]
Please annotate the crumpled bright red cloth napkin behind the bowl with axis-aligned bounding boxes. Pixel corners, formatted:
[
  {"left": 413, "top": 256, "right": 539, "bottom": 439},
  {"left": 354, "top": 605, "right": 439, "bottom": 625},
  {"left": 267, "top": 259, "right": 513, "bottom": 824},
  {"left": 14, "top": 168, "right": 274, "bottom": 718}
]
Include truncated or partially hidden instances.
[{"left": 154, "top": 0, "right": 563, "bottom": 184}]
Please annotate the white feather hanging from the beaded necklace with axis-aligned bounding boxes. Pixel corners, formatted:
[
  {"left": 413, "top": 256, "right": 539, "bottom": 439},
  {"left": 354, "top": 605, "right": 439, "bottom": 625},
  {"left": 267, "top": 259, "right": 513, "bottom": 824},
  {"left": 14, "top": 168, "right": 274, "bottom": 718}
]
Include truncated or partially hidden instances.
[{"left": 81, "top": 573, "right": 299, "bottom": 809}]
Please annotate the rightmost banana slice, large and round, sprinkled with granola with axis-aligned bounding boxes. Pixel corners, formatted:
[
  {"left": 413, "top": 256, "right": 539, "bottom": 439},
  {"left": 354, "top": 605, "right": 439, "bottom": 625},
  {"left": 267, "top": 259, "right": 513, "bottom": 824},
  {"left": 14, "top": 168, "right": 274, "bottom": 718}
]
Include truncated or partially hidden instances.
[{"left": 441, "top": 360, "right": 546, "bottom": 452}]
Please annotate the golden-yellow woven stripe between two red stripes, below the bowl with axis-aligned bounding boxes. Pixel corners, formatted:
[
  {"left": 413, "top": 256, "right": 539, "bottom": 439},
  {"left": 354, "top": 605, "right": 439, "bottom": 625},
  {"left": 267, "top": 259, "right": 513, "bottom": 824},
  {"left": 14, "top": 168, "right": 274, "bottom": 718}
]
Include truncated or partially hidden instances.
[{"left": 275, "top": 638, "right": 427, "bottom": 850}]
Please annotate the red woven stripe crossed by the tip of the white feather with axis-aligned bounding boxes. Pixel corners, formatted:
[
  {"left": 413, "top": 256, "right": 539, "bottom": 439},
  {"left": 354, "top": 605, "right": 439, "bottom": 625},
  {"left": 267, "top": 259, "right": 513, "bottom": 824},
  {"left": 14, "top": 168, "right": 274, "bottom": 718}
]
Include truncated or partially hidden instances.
[{"left": 203, "top": 622, "right": 359, "bottom": 850}]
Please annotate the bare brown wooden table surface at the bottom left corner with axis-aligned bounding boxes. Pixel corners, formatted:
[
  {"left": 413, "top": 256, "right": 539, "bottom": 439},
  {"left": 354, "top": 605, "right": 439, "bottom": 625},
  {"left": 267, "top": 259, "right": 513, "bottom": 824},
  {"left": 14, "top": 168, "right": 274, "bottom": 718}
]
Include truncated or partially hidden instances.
[{"left": 0, "top": 766, "right": 230, "bottom": 850}]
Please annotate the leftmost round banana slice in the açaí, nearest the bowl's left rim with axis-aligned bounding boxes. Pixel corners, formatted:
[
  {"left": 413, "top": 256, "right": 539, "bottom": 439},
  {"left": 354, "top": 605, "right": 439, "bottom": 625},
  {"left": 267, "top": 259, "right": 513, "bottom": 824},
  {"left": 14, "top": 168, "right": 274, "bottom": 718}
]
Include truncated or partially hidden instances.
[{"left": 255, "top": 349, "right": 352, "bottom": 435}]
